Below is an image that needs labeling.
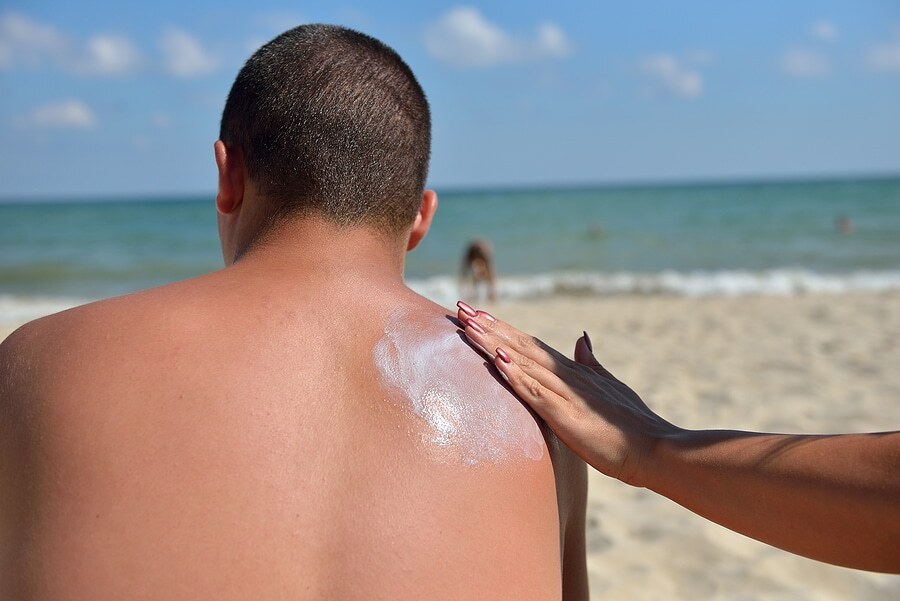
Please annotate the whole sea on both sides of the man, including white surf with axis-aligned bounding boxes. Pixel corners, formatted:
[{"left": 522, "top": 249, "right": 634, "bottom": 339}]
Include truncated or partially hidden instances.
[{"left": 0, "top": 178, "right": 900, "bottom": 321}]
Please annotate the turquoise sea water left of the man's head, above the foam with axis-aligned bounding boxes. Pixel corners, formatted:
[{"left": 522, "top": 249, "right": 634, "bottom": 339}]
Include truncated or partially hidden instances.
[{"left": 0, "top": 198, "right": 222, "bottom": 298}]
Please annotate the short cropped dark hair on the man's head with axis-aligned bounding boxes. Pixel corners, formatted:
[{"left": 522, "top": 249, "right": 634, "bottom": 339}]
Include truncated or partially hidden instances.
[{"left": 219, "top": 25, "right": 431, "bottom": 234}]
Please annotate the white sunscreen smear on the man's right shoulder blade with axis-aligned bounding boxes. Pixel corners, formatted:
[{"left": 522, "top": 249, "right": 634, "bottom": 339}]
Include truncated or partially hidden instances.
[{"left": 373, "top": 309, "right": 544, "bottom": 465}]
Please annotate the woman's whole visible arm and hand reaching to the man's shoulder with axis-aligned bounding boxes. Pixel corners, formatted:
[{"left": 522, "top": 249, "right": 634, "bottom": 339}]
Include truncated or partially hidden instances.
[{"left": 458, "top": 302, "right": 900, "bottom": 573}]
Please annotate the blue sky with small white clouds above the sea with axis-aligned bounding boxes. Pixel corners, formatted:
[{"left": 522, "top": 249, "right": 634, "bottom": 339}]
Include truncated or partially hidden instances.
[{"left": 0, "top": 0, "right": 900, "bottom": 198}]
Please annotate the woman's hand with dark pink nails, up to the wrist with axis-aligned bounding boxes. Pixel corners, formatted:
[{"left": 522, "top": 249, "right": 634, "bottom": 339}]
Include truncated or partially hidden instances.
[{"left": 457, "top": 301, "right": 681, "bottom": 486}]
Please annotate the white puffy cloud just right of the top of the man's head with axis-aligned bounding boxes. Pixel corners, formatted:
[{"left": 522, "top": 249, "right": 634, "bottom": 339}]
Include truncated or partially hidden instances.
[{"left": 425, "top": 6, "right": 572, "bottom": 67}]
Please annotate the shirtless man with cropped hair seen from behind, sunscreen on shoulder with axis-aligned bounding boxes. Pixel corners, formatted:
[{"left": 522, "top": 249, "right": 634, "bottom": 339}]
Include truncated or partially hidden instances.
[{"left": 0, "top": 25, "right": 587, "bottom": 601}]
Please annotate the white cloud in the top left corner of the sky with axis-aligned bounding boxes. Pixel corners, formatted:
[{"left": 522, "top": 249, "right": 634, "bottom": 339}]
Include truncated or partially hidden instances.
[{"left": 0, "top": 13, "right": 139, "bottom": 75}]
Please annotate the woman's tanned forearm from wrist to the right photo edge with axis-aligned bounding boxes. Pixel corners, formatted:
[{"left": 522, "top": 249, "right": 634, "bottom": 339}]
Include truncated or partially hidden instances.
[{"left": 634, "top": 430, "right": 900, "bottom": 572}]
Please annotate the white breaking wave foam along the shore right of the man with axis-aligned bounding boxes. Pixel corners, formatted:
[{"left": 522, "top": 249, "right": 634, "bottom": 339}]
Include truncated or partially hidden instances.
[{"left": 407, "top": 269, "right": 900, "bottom": 306}]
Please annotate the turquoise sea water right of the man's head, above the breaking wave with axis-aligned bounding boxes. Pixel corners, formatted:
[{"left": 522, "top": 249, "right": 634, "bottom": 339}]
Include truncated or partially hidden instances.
[{"left": 420, "top": 180, "right": 900, "bottom": 277}]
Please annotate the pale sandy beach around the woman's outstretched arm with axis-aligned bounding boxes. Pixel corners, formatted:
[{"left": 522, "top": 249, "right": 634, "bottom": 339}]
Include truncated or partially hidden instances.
[{"left": 0, "top": 292, "right": 900, "bottom": 600}]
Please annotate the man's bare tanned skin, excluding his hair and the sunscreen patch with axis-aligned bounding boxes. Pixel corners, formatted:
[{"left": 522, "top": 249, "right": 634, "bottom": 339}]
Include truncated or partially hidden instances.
[{"left": 0, "top": 144, "right": 587, "bottom": 600}]
